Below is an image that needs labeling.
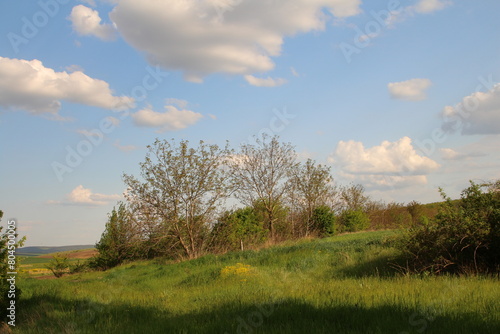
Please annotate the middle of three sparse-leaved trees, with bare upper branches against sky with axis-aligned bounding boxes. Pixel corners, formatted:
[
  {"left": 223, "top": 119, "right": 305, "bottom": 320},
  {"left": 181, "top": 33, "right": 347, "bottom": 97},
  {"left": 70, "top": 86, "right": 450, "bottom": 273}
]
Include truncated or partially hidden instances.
[{"left": 230, "top": 136, "right": 297, "bottom": 240}]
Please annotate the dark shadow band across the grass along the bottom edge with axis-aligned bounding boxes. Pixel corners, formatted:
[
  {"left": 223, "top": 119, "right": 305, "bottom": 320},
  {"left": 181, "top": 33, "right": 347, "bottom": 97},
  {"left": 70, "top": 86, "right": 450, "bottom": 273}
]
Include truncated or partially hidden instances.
[{"left": 14, "top": 295, "right": 500, "bottom": 334}]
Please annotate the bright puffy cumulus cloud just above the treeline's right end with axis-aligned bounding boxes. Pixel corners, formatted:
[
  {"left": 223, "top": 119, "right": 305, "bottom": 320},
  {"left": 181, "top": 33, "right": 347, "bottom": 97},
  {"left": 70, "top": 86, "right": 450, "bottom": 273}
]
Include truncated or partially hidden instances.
[{"left": 329, "top": 137, "right": 439, "bottom": 187}]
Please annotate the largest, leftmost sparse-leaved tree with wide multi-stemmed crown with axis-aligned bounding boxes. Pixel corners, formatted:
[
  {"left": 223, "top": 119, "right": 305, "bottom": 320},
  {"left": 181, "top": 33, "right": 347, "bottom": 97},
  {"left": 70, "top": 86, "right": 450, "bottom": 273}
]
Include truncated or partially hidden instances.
[{"left": 124, "top": 140, "right": 232, "bottom": 258}]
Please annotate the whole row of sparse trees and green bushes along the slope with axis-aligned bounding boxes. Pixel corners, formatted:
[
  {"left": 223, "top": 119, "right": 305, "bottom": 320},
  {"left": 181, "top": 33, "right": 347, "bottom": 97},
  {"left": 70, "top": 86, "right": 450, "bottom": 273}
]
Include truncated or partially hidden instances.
[{"left": 92, "top": 137, "right": 438, "bottom": 269}]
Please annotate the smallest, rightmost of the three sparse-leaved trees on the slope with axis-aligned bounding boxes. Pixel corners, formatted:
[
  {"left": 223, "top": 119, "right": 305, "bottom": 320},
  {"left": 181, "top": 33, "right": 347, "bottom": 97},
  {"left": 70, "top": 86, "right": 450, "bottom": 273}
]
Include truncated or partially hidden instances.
[{"left": 291, "top": 159, "right": 335, "bottom": 235}]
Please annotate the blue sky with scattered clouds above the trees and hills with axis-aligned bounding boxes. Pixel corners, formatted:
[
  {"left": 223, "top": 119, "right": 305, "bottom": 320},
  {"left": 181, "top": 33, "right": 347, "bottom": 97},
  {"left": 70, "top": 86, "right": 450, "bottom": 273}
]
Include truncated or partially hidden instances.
[{"left": 0, "top": 0, "right": 500, "bottom": 245}]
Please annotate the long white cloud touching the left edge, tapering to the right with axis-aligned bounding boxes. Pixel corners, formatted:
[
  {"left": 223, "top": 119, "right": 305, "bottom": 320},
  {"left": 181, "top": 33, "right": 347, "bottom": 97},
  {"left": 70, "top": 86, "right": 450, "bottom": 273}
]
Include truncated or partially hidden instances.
[{"left": 0, "top": 57, "right": 134, "bottom": 114}]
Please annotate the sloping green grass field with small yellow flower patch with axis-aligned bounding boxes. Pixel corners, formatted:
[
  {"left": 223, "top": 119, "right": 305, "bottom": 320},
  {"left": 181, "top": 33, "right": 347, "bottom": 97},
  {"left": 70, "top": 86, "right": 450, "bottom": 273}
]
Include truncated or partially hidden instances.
[{"left": 14, "top": 231, "right": 500, "bottom": 334}]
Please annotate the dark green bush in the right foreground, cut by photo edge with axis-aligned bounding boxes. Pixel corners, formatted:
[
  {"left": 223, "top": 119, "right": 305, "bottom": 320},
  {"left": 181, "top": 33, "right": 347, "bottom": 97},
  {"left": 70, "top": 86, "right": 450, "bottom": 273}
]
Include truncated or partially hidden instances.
[{"left": 397, "top": 182, "right": 500, "bottom": 273}]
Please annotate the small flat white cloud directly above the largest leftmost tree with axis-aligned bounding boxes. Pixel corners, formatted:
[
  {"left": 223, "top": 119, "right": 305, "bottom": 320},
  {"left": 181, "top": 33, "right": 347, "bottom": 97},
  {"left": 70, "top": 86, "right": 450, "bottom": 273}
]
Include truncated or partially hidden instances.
[{"left": 132, "top": 105, "right": 203, "bottom": 132}]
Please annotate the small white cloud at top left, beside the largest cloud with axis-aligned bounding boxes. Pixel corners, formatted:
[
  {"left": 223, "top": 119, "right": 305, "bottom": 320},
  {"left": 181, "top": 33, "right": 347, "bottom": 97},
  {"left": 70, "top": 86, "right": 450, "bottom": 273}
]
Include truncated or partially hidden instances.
[{"left": 69, "top": 5, "right": 116, "bottom": 41}]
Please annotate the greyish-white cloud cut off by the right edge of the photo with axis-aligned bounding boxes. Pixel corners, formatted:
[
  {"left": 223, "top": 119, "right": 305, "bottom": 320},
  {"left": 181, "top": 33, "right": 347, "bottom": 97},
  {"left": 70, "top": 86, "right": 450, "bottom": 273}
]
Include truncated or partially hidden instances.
[{"left": 442, "top": 83, "right": 500, "bottom": 135}]
